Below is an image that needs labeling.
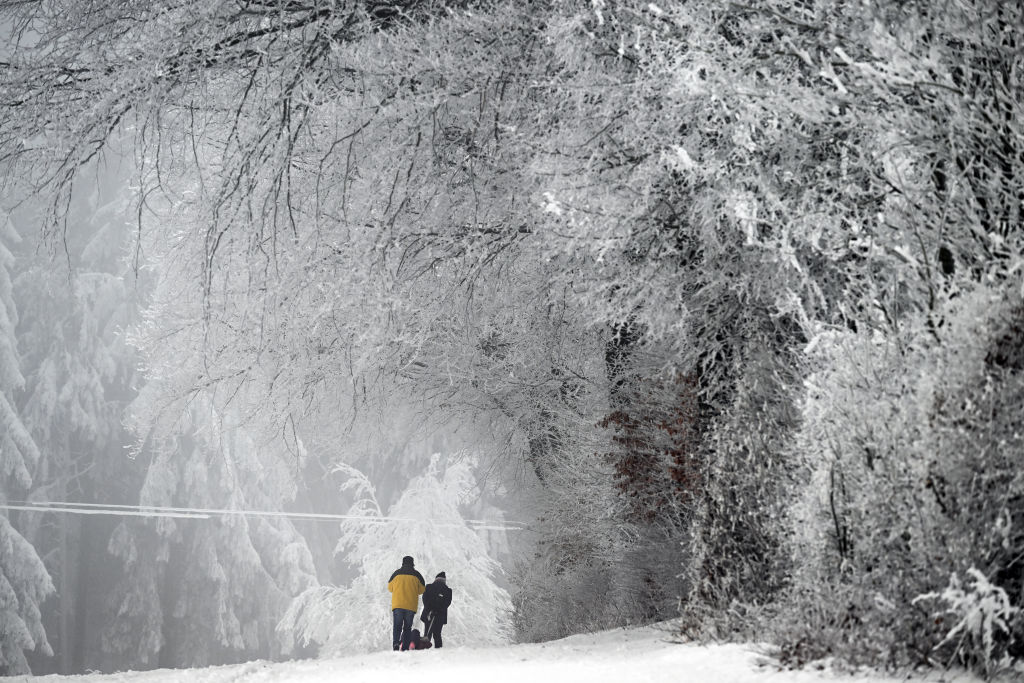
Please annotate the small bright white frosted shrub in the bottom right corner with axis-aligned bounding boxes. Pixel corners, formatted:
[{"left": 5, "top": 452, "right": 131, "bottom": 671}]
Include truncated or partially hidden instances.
[{"left": 914, "top": 566, "right": 1021, "bottom": 676}]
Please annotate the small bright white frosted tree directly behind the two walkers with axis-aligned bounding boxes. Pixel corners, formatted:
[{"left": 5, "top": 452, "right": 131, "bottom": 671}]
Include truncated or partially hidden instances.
[{"left": 279, "top": 453, "right": 512, "bottom": 655}]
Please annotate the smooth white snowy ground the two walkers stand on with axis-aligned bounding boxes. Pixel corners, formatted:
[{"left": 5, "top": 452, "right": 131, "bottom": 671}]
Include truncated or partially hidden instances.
[{"left": 19, "top": 628, "right": 980, "bottom": 683}]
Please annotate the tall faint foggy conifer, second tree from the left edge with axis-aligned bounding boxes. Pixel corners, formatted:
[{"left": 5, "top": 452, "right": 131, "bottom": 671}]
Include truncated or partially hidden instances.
[{"left": 6, "top": 157, "right": 145, "bottom": 673}]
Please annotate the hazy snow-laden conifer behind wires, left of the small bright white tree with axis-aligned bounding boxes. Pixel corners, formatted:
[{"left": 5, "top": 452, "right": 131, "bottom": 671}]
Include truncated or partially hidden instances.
[{"left": 104, "top": 393, "right": 317, "bottom": 666}]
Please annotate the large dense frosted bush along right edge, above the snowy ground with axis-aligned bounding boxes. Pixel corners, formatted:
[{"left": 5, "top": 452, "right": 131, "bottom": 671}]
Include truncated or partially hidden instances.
[{"left": 778, "top": 289, "right": 1024, "bottom": 674}]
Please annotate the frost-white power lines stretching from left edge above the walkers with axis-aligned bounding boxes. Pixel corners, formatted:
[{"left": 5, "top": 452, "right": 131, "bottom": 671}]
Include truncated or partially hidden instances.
[{"left": 0, "top": 501, "right": 526, "bottom": 531}]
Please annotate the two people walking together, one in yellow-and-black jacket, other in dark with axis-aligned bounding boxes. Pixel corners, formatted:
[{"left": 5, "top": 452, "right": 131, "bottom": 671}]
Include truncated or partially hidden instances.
[{"left": 387, "top": 555, "right": 452, "bottom": 650}]
